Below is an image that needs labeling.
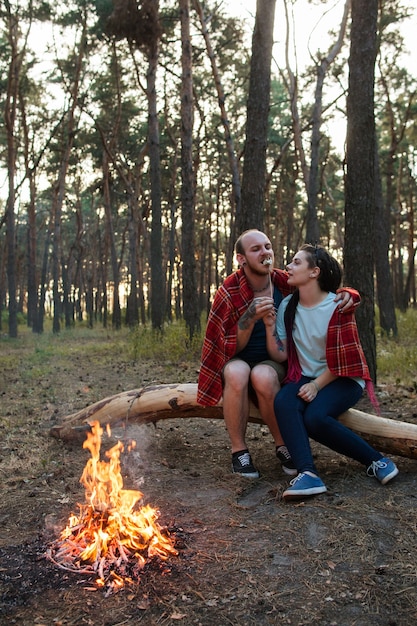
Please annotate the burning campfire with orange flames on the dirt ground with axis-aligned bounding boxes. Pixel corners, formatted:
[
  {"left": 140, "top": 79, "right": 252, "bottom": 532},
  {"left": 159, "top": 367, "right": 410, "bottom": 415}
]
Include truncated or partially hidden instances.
[{"left": 46, "top": 422, "right": 178, "bottom": 593}]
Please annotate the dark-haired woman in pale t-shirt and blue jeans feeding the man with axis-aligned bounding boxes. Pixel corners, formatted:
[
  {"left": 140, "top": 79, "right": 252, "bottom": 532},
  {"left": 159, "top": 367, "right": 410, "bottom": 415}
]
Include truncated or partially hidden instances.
[{"left": 267, "top": 244, "right": 398, "bottom": 500}]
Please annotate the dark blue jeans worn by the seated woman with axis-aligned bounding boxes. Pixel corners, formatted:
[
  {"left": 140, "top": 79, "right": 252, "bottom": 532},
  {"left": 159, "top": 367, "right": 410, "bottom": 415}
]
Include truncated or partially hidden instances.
[{"left": 274, "top": 376, "right": 382, "bottom": 474}]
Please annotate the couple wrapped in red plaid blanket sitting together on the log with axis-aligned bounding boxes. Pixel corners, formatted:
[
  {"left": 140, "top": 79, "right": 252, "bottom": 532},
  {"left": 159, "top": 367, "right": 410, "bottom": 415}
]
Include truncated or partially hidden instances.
[{"left": 197, "top": 229, "right": 398, "bottom": 500}]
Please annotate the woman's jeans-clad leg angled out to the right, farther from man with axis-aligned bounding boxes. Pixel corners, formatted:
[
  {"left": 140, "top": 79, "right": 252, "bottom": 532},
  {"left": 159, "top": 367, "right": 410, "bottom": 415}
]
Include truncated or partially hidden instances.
[{"left": 300, "top": 378, "right": 382, "bottom": 466}]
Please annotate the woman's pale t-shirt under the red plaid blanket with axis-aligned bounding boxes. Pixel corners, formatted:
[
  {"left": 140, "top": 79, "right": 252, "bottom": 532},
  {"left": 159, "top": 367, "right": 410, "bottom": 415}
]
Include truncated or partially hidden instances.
[{"left": 276, "top": 292, "right": 365, "bottom": 387}]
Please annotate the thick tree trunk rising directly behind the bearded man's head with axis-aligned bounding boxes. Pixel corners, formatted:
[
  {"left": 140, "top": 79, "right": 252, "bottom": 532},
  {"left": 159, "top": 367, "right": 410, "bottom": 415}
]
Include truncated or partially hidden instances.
[{"left": 238, "top": 0, "right": 276, "bottom": 232}]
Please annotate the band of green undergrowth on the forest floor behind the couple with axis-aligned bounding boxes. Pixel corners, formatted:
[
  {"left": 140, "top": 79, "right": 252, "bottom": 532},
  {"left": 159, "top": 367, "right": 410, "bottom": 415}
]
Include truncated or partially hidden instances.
[{"left": 0, "top": 309, "right": 417, "bottom": 389}]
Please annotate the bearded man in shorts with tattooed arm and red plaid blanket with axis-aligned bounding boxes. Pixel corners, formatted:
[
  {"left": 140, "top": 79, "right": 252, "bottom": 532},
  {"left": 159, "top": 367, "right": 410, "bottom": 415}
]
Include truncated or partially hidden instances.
[{"left": 197, "top": 229, "right": 359, "bottom": 478}]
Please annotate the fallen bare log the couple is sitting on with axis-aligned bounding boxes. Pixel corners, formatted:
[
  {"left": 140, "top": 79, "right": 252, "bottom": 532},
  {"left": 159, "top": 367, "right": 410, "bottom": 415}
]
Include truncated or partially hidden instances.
[{"left": 50, "top": 383, "right": 417, "bottom": 459}]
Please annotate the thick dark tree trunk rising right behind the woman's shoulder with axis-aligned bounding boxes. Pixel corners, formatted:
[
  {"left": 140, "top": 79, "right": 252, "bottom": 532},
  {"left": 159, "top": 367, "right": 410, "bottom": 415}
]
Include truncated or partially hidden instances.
[{"left": 344, "top": 0, "right": 378, "bottom": 381}]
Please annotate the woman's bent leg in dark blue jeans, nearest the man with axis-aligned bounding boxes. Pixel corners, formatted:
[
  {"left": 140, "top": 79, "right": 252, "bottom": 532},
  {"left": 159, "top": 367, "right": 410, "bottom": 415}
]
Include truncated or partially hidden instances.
[{"left": 274, "top": 378, "right": 317, "bottom": 474}]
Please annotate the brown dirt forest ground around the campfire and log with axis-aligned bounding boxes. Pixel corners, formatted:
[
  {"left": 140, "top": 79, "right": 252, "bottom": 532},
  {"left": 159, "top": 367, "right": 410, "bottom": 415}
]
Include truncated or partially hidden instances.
[{"left": 0, "top": 326, "right": 417, "bottom": 626}]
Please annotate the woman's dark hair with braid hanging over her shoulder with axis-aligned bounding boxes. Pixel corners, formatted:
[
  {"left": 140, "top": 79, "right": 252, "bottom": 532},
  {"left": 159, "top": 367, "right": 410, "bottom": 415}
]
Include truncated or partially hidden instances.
[{"left": 284, "top": 243, "right": 342, "bottom": 339}]
